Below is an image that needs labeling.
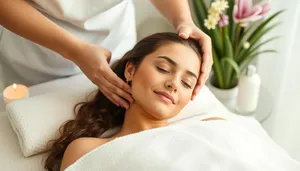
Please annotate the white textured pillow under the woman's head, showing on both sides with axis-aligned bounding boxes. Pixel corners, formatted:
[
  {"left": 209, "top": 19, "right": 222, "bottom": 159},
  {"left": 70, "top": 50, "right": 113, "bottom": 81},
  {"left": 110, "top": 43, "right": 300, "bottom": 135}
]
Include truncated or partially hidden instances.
[{"left": 6, "top": 75, "right": 217, "bottom": 157}]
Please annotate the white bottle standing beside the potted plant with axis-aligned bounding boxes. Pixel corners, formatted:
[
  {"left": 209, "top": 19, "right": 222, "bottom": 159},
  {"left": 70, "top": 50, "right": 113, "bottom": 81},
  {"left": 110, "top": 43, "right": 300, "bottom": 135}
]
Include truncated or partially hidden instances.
[{"left": 235, "top": 65, "right": 261, "bottom": 115}]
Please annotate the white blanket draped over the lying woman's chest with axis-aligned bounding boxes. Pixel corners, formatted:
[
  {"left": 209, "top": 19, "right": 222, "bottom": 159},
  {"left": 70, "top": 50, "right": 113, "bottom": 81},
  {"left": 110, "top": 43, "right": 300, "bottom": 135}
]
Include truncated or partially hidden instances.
[{"left": 66, "top": 120, "right": 300, "bottom": 171}]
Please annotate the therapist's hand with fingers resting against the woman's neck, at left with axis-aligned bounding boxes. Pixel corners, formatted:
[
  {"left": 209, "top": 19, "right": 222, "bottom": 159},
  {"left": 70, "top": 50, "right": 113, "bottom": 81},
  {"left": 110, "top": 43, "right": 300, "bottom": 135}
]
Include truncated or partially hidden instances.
[{"left": 73, "top": 44, "right": 133, "bottom": 109}]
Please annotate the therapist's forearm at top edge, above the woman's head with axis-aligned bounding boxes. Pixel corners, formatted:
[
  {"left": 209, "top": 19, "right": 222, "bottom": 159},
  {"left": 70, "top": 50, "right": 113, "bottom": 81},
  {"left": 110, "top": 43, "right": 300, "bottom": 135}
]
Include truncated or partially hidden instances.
[{"left": 151, "top": 0, "right": 193, "bottom": 29}]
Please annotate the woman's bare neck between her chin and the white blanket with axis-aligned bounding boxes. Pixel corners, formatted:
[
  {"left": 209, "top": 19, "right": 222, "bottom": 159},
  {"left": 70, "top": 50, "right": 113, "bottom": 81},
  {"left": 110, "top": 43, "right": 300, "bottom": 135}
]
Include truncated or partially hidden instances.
[{"left": 114, "top": 103, "right": 168, "bottom": 137}]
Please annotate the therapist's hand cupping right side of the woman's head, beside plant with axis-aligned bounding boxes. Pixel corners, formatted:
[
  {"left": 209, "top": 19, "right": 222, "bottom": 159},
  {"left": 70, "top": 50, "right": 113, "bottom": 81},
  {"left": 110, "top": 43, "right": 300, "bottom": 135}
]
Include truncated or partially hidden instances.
[{"left": 177, "top": 23, "right": 213, "bottom": 100}]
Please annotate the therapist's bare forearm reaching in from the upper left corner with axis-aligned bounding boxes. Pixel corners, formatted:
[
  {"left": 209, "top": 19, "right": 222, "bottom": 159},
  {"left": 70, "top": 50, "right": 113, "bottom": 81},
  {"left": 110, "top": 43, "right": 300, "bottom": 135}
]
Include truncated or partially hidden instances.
[{"left": 0, "top": 0, "right": 83, "bottom": 60}]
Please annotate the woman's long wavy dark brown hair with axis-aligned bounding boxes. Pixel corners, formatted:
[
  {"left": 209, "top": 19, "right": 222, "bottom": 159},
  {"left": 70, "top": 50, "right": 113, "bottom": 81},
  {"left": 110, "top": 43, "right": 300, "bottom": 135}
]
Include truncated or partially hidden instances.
[{"left": 45, "top": 33, "right": 201, "bottom": 171}]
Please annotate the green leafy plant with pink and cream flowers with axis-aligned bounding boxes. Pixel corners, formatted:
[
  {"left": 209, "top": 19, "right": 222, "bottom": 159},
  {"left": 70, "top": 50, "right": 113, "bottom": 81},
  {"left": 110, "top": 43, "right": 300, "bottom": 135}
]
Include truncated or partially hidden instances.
[{"left": 193, "top": 0, "right": 283, "bottom": 89}]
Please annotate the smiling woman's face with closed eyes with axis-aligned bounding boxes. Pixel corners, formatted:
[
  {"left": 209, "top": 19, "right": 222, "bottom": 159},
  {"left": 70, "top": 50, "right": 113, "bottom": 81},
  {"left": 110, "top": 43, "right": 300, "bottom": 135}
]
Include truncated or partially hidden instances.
[{"left": 127, "top": 43, "right": 200, "bottom": 120}]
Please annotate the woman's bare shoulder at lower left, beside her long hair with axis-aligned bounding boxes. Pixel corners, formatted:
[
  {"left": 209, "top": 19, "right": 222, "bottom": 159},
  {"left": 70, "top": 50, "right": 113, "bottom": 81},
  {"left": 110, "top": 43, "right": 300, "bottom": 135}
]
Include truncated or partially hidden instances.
[{"left": 60, "top": 137, "right": 109, "bottom": 171}]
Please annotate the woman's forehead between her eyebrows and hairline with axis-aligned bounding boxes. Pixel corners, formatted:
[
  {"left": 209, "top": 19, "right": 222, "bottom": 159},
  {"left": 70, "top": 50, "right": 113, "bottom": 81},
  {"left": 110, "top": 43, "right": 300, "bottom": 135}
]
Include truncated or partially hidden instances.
[{"left": 146, "top": 43, "right": 200, "bottom": 74}]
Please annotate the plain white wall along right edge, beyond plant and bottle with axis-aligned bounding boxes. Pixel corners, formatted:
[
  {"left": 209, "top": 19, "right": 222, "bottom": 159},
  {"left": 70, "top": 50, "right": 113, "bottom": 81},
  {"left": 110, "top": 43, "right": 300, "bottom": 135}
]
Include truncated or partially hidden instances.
[{"left": 258, "top": 0, "right": 300, "bottom": 161}]
